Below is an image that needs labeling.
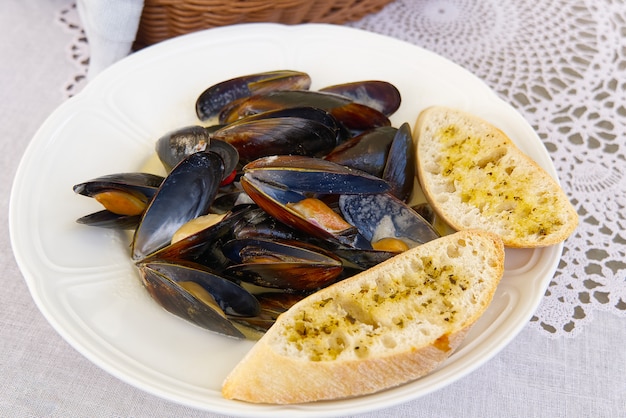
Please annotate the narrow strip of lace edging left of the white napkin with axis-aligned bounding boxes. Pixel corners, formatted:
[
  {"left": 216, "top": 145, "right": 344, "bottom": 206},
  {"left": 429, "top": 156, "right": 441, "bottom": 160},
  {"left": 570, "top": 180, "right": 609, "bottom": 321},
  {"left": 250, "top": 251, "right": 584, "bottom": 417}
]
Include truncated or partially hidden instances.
[{"left": 55, "top": 2, "right": 89, "bottom": 98}]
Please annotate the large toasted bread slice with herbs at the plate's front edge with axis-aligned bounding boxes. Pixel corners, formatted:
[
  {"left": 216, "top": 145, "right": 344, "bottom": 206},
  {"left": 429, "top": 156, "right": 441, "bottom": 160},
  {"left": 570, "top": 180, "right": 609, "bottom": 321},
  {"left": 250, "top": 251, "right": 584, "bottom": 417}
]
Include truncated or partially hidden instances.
[{"left": 222, "top": 231, "right": 504, "bottom": 404}]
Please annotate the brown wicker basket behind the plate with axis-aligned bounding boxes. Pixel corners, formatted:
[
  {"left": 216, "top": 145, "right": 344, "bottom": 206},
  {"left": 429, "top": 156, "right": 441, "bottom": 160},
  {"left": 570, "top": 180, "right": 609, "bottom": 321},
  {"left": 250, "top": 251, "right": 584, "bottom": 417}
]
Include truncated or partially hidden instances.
[{"left": 134, "top": 0, "right": 391, "bottom": 49}]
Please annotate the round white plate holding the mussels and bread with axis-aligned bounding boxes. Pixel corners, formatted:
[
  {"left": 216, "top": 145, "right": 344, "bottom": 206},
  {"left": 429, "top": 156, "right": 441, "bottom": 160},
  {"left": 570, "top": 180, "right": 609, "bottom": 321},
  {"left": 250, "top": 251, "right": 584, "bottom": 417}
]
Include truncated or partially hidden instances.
[{"left": 10, "top": 24, "right": 562, "bottom": 417}]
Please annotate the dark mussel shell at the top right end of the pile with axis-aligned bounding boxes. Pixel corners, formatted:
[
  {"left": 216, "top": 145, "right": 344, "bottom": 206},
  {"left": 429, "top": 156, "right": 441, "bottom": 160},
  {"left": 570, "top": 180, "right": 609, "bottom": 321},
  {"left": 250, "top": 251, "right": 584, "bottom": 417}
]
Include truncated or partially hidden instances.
[{"left": 319, "top": 80, "right": 402, "bottom": 116}]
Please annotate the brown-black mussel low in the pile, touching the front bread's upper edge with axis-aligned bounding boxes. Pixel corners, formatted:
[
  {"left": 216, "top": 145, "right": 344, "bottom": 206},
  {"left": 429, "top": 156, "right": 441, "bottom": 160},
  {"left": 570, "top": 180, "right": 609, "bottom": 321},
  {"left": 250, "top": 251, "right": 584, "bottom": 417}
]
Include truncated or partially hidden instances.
[{"left": 223, "top": 239, "right": 343, "bottom": 291}]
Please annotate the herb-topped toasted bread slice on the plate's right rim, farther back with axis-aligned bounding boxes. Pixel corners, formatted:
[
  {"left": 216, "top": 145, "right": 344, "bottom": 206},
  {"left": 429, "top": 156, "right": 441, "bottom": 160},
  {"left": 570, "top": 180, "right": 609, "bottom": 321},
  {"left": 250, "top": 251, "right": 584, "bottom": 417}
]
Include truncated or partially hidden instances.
[{"left": 414, "top": 107, "right": 578, "bottom": 247}]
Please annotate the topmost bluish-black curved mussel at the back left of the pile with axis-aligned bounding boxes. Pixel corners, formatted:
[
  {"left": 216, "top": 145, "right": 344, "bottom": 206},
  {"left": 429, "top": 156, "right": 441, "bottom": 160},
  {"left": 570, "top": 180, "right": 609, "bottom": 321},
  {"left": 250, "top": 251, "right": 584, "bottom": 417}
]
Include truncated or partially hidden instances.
[{"left": 196, "top": 70, "right": 311, "bottom": 120}]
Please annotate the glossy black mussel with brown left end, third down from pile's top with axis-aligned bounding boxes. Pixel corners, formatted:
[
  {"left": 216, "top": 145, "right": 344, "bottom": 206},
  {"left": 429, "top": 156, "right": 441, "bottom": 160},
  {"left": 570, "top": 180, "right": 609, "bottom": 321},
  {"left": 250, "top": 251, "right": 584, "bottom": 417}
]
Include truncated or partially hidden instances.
[{"left": 211, "top": 116, "right": 337, "bottom": 164}]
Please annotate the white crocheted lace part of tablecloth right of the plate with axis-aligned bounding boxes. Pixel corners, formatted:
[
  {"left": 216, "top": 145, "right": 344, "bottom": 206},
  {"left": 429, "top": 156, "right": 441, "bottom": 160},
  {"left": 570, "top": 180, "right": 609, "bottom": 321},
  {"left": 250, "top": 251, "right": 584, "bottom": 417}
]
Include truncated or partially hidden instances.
[{"left": 351, "top": 0, "right": 626, "bottom": 336}]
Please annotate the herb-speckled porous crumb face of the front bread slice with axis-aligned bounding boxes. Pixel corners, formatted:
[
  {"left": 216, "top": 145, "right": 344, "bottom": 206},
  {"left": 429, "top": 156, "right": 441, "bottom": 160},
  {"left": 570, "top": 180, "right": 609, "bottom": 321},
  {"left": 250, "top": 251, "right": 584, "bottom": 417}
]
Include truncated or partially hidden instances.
[{"left": 273, "top": 238, "right": 499, "bottom": 361}]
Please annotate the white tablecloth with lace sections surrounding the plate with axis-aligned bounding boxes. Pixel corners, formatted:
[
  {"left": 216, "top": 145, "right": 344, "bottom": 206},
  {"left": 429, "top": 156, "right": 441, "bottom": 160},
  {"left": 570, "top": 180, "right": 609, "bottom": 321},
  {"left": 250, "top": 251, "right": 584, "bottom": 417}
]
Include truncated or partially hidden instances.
[{"left": 0, "top": 0, "right": 626, "bottom": 417}]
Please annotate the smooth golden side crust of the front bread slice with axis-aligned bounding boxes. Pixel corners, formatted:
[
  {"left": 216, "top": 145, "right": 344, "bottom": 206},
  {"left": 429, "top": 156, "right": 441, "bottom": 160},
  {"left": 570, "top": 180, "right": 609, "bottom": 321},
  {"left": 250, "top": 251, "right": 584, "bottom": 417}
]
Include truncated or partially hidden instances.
[{"left": 222, "top": 327, "right": 470, "bottom": 404}]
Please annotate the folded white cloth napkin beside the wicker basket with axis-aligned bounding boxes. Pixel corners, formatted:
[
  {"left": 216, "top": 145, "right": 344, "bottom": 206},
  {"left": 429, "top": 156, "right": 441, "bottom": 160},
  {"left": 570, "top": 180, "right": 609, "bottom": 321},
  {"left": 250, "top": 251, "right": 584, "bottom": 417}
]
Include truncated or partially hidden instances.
[{"left": 76, "top": 0, "right": 144, "bottom": 80}]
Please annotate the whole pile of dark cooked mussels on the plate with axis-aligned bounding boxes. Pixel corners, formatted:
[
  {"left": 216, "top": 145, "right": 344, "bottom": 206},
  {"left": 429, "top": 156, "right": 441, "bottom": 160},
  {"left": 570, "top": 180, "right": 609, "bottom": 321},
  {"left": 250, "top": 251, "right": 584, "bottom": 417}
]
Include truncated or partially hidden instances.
[{"left": 74, "top": 70, "right": 438, "bottom": 338}]
